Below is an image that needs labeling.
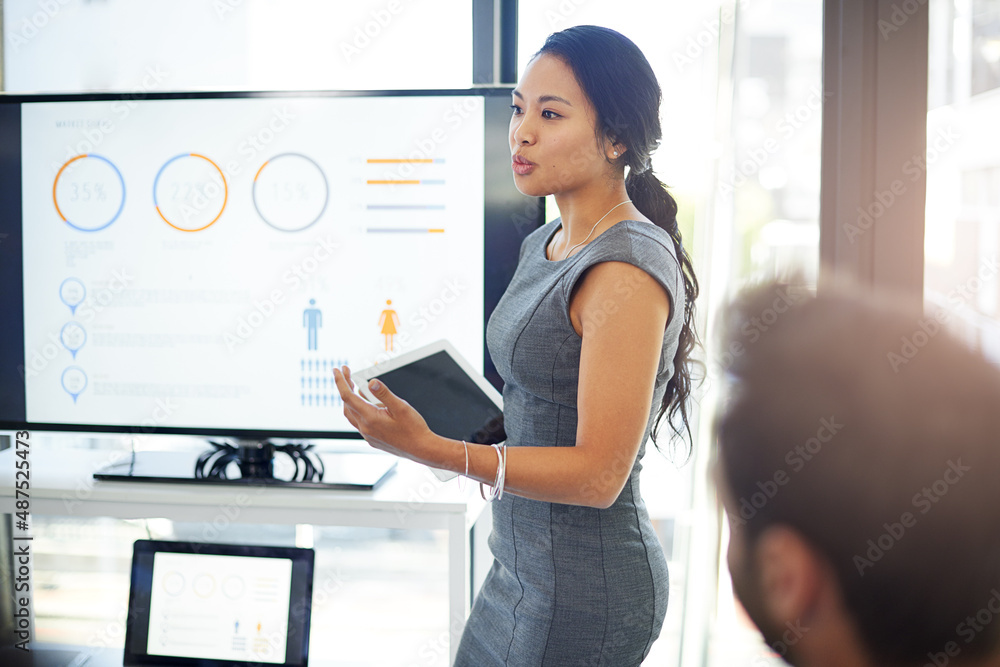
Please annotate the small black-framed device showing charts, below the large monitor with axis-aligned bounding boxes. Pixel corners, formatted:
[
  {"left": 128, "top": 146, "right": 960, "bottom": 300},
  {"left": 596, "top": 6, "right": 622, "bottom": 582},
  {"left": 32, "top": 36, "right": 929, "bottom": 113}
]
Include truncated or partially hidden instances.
[{"left": 124, "top": 540, "right": 314, "bottom": 667}]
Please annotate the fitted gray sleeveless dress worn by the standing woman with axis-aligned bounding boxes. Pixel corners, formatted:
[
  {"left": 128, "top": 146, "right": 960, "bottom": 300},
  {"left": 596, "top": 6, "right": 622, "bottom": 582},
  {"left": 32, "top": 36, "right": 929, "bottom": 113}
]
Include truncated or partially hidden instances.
[{"left": 454, "top": 221, "right": 684, "bottom": 667}]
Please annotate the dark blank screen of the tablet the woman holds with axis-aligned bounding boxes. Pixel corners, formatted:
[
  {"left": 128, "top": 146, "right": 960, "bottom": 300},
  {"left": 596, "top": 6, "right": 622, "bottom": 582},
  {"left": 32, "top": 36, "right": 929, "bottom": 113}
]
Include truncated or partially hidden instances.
[{"left": 377, "top": 351, "right": 507, "bottom": 444}]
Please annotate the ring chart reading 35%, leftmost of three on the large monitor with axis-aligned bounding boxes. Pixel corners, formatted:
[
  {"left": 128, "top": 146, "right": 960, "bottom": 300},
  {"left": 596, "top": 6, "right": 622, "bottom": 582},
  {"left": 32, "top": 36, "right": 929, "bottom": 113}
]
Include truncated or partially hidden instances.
[{"left": 52, "top": 153, "right": 125, "bottom": 232}]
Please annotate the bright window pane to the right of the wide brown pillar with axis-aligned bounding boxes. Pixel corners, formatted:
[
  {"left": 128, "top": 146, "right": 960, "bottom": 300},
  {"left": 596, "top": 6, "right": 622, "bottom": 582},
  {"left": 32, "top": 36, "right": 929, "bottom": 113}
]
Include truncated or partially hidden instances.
[{"left": 924, "top": 0, "right": 1000, "bottom": 363}]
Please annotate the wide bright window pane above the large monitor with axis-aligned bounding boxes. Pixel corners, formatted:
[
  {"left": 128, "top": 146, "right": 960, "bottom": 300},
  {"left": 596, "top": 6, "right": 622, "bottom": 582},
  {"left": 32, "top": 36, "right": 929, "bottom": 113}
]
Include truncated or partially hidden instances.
[{"left": 3, "top": 0, "right": 472, "bottom": 92}]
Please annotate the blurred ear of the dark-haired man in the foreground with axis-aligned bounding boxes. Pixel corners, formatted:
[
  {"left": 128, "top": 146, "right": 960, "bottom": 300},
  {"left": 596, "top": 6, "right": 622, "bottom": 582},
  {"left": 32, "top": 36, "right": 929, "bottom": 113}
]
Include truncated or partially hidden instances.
[{"left": 754, "top": 526, "right": 827, "bottom": 624}]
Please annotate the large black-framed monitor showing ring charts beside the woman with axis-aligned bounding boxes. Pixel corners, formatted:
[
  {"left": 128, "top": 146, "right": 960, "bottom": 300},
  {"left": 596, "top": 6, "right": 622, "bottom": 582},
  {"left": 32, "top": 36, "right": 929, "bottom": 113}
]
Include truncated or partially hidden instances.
[{"left": 0, "top": 88, "right": 542, "bottom": 438}]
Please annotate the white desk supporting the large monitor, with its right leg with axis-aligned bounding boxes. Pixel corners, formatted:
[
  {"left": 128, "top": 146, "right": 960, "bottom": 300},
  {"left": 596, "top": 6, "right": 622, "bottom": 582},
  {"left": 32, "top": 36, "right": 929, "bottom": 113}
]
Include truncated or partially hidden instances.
[{"left": 0, "top": 440, "right": 486, "bottom": 659}]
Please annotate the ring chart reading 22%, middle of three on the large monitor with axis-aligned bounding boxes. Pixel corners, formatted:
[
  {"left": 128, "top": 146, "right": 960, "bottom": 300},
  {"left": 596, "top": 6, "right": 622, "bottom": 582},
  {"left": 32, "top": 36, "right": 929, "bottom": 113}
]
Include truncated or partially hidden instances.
[{"left": 153, "top": 153, "right": 229, "bottom": 232}]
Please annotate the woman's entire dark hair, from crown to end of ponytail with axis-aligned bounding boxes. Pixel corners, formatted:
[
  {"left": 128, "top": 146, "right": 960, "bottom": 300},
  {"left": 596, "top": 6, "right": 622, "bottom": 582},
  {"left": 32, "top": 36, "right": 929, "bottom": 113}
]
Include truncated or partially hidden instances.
[{"left": 534, "top": 25, "right": 699, "bottom": 460}]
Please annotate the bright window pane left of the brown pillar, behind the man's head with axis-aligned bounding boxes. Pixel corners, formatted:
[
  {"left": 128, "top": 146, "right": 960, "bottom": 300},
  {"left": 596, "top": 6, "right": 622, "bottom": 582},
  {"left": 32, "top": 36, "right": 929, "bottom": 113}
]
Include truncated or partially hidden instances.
[{"left": 706, "top": 0, "right": 825, "bottom": 667}]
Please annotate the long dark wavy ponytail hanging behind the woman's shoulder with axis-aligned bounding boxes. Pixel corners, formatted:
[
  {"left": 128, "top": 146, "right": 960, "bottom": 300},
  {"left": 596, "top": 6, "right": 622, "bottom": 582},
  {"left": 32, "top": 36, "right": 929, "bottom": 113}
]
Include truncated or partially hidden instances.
[{"left": 625, "top": 163, "right": 699, "bottom": 461}]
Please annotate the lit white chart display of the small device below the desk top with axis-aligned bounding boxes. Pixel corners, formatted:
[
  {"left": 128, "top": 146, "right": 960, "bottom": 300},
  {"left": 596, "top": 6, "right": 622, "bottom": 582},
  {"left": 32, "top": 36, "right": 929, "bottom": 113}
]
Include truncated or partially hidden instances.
[{"left": 146, "top": 553, "right": 292, "bottom": 663}]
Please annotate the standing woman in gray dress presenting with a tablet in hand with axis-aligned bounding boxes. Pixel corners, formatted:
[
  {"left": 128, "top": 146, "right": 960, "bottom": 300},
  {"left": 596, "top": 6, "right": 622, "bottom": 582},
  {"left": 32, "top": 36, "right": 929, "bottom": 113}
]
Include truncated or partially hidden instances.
[{"left": 335, "top": 26, "right": 698, "bottom": 667}]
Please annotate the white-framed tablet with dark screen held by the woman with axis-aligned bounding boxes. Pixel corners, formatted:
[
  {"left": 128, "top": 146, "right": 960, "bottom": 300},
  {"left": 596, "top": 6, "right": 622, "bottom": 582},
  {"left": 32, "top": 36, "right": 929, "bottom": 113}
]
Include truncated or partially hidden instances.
[{"left": 351, "top": 340, "right": 507, "bottom": 480}]
